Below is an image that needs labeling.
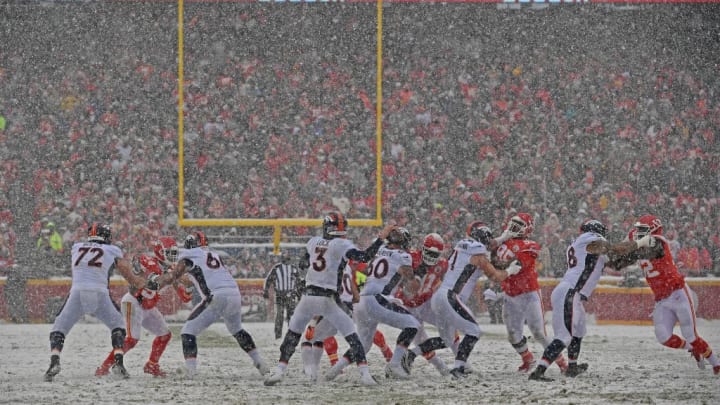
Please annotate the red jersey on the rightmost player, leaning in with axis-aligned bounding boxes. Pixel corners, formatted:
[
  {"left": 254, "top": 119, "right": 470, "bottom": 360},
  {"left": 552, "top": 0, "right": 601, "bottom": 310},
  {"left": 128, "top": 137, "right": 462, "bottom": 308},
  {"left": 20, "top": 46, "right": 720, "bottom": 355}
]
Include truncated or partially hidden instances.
[{"left": 639, "top": 236, "right": 685, "bottom": 301}]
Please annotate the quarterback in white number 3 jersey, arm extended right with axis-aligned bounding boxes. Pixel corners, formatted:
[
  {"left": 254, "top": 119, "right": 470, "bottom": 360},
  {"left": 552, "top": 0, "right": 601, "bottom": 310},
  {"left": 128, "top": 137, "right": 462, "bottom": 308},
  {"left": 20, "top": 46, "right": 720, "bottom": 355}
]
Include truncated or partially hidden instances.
[{"left": 265, "top": 212, "right": 395, "bottom": 385}]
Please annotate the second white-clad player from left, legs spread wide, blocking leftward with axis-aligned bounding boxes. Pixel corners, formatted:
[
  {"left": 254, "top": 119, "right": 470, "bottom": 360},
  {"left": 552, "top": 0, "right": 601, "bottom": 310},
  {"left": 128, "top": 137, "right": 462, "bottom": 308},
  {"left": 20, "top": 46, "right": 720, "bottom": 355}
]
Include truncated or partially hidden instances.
[{"left": 156, "top": 231, "right": 270, "bottom": 379}]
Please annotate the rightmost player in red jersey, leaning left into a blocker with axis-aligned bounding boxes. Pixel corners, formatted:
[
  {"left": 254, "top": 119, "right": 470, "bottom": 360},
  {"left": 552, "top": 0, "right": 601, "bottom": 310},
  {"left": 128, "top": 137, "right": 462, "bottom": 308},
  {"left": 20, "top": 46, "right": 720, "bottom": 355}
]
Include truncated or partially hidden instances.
[{"left": 613, "top": 215, "right": 720, "bottom": 374}]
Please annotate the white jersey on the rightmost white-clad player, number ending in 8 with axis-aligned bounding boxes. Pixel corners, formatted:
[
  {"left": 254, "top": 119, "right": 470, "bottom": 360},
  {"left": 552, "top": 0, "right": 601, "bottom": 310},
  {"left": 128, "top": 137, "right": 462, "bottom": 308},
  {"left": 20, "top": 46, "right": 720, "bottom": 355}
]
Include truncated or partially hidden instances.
[{"left": 562, "top": 232, "right": 607, "bottom": 297}]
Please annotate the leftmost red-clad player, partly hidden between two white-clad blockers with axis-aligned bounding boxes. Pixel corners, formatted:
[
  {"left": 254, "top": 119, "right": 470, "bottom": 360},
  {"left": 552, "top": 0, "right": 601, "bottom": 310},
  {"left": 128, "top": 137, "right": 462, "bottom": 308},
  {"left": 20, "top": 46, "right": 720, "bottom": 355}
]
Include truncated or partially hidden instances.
[{"left": 95, "top": 236, "right": 193, "bottom": 377}]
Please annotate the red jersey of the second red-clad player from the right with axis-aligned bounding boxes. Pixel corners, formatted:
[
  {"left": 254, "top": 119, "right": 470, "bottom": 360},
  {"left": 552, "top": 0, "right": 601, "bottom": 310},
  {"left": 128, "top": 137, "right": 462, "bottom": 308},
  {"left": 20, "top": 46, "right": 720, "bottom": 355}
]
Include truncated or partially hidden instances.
[{"left": 497, "top": 239, "right": 540, "bottom": 297}]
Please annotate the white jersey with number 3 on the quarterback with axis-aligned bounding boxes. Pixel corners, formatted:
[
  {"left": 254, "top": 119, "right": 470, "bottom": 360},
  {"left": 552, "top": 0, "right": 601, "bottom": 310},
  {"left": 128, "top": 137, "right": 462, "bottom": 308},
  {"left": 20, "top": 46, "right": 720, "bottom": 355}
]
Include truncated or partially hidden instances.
[{"left": 305, "top": 236, "right": 357, "bottom": 292}]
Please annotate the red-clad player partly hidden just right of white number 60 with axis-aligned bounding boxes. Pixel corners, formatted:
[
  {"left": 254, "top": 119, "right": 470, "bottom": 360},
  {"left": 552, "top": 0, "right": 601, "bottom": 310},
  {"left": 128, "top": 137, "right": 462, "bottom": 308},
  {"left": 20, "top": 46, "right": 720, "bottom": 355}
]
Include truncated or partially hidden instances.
[{"left": 397, "top": 233, "right": 452, "bottom": 375}]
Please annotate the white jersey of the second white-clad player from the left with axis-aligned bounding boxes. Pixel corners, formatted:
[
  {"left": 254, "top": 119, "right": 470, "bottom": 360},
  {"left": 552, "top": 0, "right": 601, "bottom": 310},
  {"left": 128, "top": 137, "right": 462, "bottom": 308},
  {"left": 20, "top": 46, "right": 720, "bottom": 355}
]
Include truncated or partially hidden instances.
[{"left": 178, "top": 247, "right": 240, "bottom": 294}]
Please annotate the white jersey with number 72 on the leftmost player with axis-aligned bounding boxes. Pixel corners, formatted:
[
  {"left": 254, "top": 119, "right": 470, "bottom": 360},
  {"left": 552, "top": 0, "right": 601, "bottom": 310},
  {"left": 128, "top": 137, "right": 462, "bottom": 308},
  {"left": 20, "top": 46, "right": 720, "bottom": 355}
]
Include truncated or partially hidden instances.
[{"left": 70, "top": 242, "right": 123, "bottom": 290}]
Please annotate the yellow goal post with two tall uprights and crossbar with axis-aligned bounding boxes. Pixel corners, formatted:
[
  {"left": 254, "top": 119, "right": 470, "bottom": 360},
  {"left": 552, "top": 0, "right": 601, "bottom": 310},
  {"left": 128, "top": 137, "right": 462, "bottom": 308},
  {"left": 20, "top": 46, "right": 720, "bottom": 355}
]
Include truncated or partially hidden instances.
[{"left": 177, "top": 0, "right": 383, "bottom": 253}]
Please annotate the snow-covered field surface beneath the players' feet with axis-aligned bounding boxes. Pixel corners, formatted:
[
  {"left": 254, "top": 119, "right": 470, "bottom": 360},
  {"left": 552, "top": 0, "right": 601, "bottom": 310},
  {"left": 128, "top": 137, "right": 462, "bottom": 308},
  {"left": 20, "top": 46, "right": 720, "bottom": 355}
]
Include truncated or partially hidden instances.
[{"left": 0, "top": 319, "right": 720, "bottom": 404}]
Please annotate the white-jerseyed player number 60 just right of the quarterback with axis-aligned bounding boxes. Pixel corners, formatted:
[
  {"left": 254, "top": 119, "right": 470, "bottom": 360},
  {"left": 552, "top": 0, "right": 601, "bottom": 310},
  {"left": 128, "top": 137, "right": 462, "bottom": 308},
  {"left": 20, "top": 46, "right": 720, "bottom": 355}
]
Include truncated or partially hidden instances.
[{"left": 328, "top": 227, "right": 430, "bottom": 379}]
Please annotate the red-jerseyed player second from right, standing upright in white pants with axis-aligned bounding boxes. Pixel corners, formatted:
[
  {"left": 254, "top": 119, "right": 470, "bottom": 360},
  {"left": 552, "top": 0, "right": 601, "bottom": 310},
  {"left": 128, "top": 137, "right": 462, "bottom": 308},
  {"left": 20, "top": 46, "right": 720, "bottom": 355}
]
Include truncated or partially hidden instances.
[{"left": 493, "top": 212, "right": 577, "bottom": 373}]
